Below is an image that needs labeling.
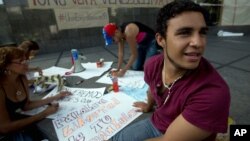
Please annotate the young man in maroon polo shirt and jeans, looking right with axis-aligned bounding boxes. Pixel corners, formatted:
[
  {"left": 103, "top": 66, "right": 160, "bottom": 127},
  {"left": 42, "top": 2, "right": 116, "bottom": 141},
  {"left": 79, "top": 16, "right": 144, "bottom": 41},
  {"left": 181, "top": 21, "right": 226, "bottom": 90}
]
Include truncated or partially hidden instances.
[{"left": 111, "top": 1, "right": 230, "bottom": 141}]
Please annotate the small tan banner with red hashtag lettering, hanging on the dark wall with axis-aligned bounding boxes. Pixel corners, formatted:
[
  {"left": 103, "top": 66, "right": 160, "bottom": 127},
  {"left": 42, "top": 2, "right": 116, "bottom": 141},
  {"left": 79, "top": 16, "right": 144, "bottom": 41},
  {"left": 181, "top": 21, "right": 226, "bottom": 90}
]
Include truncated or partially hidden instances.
[{"left": 54, "top": 8, "right": 109, "bottom": 30}]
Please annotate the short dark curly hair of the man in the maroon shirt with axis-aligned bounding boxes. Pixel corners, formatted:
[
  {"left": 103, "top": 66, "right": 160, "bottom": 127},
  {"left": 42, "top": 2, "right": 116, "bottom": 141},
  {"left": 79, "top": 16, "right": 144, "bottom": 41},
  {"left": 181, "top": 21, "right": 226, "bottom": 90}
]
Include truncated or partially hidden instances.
[{"left": 156, "top": 0, "right": 208, "bottom": 37}]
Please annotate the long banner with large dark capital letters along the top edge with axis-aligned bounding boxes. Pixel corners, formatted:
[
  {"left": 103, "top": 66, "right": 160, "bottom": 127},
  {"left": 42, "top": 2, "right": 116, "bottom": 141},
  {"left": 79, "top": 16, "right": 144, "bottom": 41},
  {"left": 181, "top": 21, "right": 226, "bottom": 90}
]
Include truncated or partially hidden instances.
[{"left": 28, "top": 0, "right": 173, "bottom": 9}]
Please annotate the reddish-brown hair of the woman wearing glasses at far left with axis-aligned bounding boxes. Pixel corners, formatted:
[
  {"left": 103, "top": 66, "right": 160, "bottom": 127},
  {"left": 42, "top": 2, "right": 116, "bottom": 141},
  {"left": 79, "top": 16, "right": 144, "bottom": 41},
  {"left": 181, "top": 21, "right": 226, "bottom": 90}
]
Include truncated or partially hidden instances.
[{"left": 0, "top": 46, "right": 25, "bottom": 75}]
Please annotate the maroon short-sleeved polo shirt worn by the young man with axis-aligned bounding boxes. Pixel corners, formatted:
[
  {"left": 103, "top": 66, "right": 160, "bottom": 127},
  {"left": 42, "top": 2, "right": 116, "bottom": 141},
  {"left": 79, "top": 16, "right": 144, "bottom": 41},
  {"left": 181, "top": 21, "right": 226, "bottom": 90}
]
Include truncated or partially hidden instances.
[{"left": 144, "top": 54, "right": 230, "bottom": 140}]
